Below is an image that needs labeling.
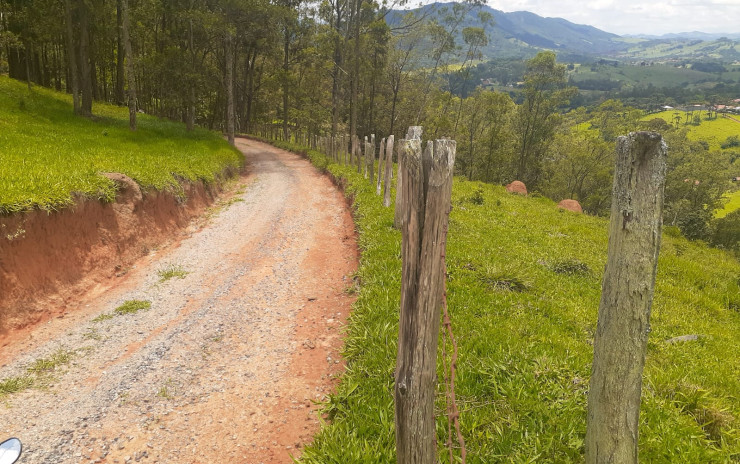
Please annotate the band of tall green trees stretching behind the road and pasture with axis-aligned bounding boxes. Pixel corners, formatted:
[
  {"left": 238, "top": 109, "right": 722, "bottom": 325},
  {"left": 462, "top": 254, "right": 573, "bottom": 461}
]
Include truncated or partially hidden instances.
[{"left": 0, "top": 0, "right": 739, "bottom": 248}]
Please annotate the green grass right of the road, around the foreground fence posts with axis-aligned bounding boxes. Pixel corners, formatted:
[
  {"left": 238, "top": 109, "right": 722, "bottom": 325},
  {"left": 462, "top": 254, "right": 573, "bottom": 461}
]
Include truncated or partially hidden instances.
[{"left": 268, "top": 136, "right": 740, "bottom": 464}]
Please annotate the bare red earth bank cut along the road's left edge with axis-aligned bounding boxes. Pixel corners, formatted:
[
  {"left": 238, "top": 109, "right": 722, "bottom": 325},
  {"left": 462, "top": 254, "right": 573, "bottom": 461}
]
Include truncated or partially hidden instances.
[{"left": 0, "top": 173, "right": 217, "bottom": 336}]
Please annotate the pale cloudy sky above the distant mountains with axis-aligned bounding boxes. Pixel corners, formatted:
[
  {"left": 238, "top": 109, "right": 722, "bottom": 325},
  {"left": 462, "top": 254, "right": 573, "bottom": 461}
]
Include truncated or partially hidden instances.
[{"left": 480, "top": 0, "right": 740, "bottom": 35}]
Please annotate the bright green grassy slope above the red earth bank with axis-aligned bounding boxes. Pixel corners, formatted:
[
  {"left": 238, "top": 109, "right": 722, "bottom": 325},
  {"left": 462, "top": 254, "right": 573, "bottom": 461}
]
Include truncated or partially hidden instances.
[{"left": 0, "top": 76, "right": 241, "bottom": 213}]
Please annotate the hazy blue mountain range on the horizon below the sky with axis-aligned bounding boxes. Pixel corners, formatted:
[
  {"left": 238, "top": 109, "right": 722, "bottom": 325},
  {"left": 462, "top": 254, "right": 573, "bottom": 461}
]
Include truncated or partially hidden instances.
[{"left": 386, "top": 3, "right": 740, "bottom": 62}]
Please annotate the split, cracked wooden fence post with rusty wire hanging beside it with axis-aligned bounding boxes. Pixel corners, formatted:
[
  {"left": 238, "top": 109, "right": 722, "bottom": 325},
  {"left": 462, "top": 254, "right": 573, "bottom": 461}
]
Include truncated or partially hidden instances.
[{"left": 395, "top": 128, "right": 455, "bottom": 464}]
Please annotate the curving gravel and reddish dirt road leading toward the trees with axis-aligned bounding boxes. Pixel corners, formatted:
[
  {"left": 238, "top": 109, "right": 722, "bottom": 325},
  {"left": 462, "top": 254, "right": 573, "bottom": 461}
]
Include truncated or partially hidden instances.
[{"left": 0, "top": 139, "right": 357, "bottom": 463}]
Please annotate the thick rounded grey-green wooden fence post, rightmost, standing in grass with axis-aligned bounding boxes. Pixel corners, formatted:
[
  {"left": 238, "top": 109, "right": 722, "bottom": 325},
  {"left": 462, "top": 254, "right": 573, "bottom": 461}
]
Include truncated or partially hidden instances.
[{"left": 586, "top": 132, "right": 666, "bottom": 464}]
